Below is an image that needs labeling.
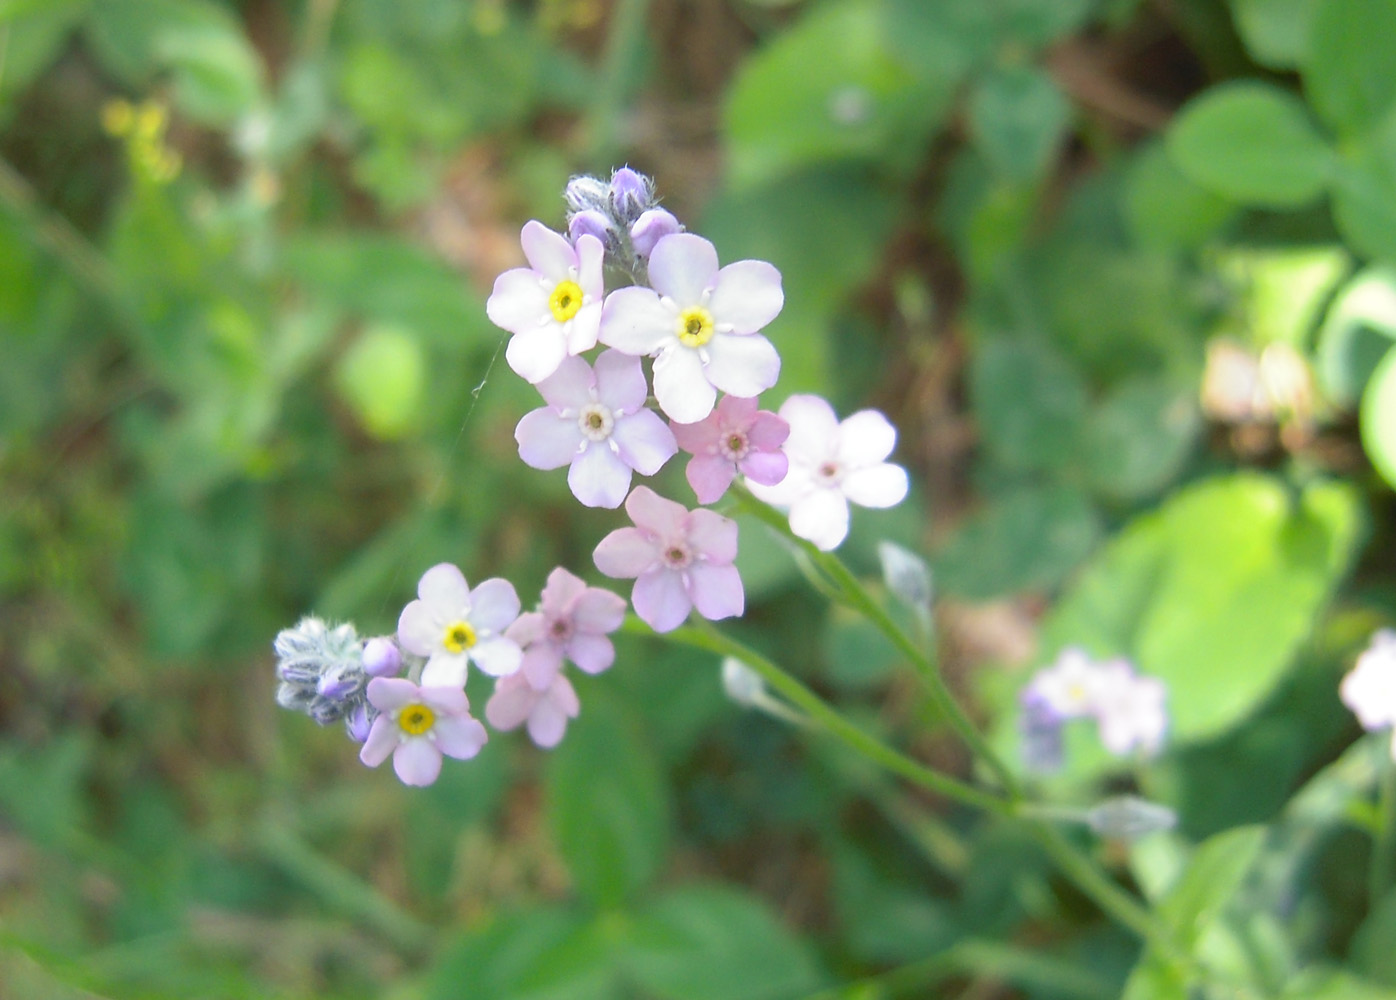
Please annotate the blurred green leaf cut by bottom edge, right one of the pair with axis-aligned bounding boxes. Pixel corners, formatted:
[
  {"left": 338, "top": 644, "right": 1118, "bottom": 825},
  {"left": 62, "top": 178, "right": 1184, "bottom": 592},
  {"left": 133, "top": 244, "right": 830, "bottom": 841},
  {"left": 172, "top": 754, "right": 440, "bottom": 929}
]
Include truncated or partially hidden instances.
[{"left": 625, "top": 885, "right": 825, "bottom": 1000}]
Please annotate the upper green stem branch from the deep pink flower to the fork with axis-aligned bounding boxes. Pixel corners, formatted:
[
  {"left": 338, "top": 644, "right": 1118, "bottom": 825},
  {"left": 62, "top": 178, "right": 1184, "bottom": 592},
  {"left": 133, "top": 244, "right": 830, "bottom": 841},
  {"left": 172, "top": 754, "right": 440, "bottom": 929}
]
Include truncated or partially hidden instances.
[{"left": 734, "top": 485, "right": 1020, "bottom": 799}]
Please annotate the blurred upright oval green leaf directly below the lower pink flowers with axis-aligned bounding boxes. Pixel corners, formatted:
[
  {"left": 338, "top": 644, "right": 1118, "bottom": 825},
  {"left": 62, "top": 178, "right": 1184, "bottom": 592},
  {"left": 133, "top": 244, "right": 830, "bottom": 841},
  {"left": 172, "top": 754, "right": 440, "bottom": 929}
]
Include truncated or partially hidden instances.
[{"left": 547, "top": 698, "right": 670, "bottom": 906}]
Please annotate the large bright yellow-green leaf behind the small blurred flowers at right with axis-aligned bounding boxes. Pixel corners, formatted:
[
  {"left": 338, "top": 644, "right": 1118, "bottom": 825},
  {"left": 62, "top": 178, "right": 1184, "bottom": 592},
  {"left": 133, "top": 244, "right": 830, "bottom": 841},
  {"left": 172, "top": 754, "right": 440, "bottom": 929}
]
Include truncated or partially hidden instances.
[{"left": 1041, "top": 473, "right": 1362, "bottom": 740}]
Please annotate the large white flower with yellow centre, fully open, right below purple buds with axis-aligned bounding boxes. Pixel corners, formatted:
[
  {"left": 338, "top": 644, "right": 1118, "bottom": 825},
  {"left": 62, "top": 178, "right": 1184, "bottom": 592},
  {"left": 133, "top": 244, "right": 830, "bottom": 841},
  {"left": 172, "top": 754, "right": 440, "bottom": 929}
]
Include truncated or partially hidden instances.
[{"left": 599, "top": 233, "right": 785, "bottom": 423}]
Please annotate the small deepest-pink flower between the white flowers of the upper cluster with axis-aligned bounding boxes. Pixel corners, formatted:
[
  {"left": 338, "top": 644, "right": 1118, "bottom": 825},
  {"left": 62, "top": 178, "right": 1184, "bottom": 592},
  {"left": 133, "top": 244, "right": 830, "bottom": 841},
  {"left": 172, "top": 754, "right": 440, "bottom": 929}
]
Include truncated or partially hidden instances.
[{"left": 670, "top": 395, "right": 790, "bottom": 504}]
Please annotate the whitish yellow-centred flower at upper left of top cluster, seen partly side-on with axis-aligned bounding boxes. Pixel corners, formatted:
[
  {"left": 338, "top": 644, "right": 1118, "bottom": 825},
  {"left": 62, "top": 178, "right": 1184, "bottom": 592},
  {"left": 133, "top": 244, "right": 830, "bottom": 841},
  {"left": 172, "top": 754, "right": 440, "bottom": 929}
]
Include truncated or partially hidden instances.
[{"left": 484, "top": 221, "right": 606, "bottom": 384}]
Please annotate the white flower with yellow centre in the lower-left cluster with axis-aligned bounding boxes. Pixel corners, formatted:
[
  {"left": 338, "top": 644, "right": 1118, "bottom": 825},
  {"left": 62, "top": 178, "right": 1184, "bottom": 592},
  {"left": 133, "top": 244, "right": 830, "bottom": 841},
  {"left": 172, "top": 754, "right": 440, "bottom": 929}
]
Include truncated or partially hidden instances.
[{"left": 398, "top": 563, "right": 524, "bottom": 687}]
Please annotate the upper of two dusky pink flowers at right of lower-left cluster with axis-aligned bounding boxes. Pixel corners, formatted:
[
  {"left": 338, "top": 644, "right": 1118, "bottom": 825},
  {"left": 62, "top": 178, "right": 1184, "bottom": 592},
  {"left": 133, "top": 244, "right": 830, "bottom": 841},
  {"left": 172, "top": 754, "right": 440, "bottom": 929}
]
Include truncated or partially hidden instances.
[{"left": 505, "top": 566, "right": 625, "bottom": 691}]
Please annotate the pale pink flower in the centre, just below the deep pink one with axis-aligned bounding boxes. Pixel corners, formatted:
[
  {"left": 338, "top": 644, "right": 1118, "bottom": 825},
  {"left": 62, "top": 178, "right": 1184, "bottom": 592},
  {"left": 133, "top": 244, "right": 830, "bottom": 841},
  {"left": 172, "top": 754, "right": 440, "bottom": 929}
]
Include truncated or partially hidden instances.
[{"left": 595, "top": 486, "right": 745, "bottom": 631}]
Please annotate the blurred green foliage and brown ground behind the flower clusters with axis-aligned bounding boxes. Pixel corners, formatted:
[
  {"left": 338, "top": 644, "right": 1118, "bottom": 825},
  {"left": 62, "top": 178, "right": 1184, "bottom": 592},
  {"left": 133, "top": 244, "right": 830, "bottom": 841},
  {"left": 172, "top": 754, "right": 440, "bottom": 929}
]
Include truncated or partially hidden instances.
[{"left": 8, "top": 0, "right": 1396, "bottom": 1000}]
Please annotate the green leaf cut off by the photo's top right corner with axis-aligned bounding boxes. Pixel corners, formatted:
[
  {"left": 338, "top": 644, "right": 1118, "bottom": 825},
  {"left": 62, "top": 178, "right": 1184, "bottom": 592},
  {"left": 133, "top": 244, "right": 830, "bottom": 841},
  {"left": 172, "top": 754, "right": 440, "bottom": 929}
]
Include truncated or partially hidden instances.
[{"left": 1304, "top": 0, "right": 1396, "bottom": 137}]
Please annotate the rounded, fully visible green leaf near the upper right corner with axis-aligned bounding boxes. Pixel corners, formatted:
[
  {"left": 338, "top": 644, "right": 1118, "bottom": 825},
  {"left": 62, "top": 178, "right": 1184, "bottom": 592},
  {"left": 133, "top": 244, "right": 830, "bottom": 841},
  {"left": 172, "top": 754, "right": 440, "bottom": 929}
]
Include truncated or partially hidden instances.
[{"left": 1167, "top": 81, "right": 1333, "bottom": 208}]
